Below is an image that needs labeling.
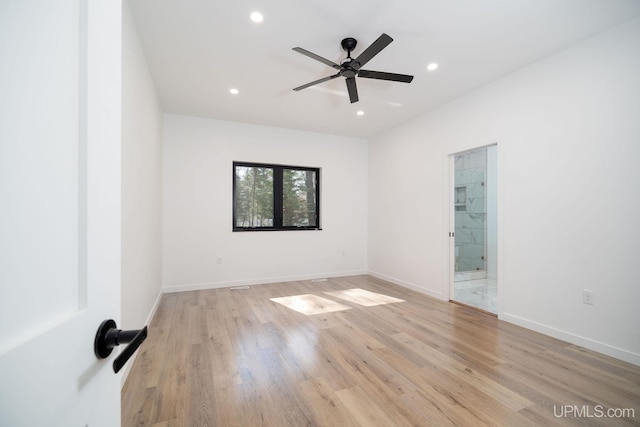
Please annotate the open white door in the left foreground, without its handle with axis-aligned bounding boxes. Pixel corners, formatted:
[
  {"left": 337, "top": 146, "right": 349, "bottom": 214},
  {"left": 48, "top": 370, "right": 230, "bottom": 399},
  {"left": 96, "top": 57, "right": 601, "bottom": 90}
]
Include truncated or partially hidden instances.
[{"left": 0, "top": 0, "right": 121, "bottom": 427}]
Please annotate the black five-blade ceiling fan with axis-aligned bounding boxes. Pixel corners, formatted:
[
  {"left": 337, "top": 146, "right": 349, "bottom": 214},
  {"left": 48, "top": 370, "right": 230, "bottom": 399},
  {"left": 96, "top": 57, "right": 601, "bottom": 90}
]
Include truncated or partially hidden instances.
[{"left": 293, "top": 33, "right": 413, "bottom": 104}]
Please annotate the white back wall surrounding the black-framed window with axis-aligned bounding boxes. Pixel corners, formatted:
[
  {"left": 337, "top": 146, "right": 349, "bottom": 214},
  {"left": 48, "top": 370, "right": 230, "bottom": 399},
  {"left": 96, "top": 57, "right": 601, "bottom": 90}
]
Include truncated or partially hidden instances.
[{"left": 163, "top": 114, "right": 367, "bottom": 291}]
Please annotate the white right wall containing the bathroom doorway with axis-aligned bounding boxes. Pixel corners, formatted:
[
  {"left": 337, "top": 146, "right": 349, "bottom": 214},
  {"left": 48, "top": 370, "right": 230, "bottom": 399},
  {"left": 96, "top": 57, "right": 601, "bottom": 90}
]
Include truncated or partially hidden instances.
[{"left": 369, "top": 19, "right": 640, "bottom": 364}]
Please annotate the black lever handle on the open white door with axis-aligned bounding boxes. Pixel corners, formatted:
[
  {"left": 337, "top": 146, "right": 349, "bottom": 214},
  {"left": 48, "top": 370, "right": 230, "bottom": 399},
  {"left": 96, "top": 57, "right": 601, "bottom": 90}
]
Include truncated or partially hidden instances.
[{"left": 93, "top": 319, "right": 147, "bottom": 373}]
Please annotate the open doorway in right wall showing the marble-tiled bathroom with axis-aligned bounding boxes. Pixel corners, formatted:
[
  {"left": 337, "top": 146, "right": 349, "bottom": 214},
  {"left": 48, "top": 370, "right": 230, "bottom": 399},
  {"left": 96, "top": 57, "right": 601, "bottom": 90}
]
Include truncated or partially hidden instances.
[{"left": 450, "top": 145, "right": 498, "bottom": 315}]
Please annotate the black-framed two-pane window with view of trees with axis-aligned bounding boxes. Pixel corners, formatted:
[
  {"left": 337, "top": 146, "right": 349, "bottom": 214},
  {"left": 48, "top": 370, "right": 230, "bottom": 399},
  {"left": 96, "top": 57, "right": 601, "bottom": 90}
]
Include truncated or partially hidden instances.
[{"left": 233, "top": 162, "right": 320, "bottom": 231}]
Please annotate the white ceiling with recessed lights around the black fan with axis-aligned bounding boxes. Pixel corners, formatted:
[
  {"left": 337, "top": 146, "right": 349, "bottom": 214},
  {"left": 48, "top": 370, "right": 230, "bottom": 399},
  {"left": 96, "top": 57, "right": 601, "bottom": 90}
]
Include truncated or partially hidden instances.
[{"left": 129, "top": 0, "right": 640, "bottom": 138}]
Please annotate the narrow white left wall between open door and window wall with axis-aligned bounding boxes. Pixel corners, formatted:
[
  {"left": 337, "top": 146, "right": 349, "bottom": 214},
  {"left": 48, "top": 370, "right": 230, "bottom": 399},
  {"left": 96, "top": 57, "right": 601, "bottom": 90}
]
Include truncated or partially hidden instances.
[{"left": 118, "top": 1, "right": 162, "bottom": 332}]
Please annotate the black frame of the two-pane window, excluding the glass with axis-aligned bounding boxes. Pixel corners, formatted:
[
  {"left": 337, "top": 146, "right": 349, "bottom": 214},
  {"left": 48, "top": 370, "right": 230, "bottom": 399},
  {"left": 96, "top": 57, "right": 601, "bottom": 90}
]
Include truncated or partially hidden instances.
[{"left": 232, "top": 161, "right": 322, "bottom": 231}]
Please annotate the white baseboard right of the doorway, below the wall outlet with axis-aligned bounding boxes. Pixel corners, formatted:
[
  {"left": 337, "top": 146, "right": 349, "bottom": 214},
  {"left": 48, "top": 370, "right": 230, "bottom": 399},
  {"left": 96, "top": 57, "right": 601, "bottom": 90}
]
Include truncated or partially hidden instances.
[{"left": 500, "top": 313, "right": 640, "bottom": 366}]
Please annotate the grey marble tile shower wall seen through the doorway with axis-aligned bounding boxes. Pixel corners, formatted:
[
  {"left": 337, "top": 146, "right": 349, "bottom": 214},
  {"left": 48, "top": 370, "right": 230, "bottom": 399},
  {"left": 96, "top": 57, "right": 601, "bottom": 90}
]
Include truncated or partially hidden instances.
[{"left": 455, "top": 149, "right": 487, "bottom": 272}]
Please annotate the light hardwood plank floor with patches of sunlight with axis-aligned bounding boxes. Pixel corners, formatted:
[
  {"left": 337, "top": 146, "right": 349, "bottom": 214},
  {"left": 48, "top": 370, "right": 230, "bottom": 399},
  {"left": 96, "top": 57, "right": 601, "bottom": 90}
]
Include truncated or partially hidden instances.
[{"left": 122, "top": 276, "right": 640, "bottom": 427}]
